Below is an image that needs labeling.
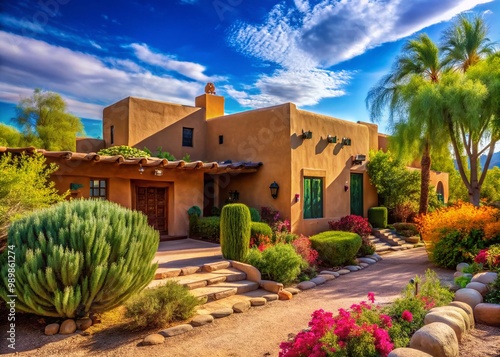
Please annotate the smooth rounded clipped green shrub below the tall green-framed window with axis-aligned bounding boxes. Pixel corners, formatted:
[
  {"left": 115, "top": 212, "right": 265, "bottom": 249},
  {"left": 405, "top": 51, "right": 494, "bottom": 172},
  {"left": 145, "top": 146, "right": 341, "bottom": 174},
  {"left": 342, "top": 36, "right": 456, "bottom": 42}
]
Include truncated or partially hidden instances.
[{"left": 310, "top": 231, "right": 361, "bottom": 266}]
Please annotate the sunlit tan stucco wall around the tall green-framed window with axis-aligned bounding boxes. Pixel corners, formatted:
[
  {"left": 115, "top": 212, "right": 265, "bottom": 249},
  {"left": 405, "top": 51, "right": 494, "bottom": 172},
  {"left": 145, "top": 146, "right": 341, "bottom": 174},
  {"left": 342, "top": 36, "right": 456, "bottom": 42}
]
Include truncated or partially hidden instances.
[{"left": 288, "top": 106, "right": 378, "bottom": 235}]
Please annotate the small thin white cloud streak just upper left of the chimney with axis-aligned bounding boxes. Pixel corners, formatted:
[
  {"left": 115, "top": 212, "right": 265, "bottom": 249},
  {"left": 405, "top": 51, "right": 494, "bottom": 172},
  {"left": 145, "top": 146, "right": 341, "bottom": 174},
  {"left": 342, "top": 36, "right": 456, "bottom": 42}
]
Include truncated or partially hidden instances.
[{"left": 130, "top": 43, "right": 222, "bottom": 82}]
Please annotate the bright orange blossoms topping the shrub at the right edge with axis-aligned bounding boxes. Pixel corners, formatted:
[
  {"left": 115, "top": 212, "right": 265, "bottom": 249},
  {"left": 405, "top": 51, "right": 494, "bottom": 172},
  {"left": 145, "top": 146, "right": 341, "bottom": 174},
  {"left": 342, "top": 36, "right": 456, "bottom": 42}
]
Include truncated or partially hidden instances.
[{"left": 416, "top": 202, "right": 500, "bottom": 246}]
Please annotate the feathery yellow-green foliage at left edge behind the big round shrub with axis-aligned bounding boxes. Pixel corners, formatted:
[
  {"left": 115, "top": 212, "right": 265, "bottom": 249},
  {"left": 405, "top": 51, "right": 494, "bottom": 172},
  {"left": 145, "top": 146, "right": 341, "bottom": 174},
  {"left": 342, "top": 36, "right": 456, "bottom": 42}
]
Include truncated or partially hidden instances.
[{"left": 0, "top": 154, "right": 67, "bottom": 251}]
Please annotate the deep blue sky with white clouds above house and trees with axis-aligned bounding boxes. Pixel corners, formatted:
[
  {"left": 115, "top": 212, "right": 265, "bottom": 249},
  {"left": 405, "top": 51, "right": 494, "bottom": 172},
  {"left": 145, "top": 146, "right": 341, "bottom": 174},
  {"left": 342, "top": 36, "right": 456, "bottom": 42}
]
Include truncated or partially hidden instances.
[{"left": 0, "top": 0, "right": 500, "bottom": 138}]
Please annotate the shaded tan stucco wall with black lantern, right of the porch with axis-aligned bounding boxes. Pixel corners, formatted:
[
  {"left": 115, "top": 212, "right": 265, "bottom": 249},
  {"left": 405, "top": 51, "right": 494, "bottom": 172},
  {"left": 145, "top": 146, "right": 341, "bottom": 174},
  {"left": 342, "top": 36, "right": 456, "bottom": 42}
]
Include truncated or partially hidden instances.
[{"left": 207, "top": 103, "right": 292, "bottom": 217}]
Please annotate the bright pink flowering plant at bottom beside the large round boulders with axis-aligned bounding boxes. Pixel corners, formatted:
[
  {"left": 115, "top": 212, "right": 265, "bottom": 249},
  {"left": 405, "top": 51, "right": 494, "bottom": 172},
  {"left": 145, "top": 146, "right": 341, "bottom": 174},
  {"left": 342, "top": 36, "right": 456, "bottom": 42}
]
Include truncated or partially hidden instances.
[{"left": 279, "top": 293, "right": 393, "bottom": 357}]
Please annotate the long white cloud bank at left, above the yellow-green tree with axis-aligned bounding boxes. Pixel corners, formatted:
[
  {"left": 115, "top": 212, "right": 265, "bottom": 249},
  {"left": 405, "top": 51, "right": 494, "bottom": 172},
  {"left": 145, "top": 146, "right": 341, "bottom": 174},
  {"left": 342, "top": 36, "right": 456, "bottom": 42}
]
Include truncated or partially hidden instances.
[{"left": 0, "top": 31, "right": 221, "bottom": 118}]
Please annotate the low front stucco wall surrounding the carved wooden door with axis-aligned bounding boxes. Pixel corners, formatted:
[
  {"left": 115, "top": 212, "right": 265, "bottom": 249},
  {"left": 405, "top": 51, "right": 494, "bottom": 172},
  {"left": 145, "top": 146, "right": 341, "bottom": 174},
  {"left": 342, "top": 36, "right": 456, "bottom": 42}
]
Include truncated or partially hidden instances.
[{"left": 47, "top": 158, "right": 203, "bottom": 236}]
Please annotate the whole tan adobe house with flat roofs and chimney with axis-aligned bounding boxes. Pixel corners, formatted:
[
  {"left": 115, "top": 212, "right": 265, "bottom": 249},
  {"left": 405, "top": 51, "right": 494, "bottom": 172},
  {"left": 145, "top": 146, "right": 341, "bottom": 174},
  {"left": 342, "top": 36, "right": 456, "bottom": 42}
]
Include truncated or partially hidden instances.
[{"left": 2, "top": 85, "right": 448, "bottom": 237}]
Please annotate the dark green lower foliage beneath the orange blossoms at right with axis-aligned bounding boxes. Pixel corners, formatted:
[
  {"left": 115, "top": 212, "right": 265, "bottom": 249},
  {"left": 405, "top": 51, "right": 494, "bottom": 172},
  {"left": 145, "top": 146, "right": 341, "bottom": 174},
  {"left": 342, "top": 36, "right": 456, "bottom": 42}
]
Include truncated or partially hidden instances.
[{"left": 429, "top": 229, "right": 494, "bottom": 268}]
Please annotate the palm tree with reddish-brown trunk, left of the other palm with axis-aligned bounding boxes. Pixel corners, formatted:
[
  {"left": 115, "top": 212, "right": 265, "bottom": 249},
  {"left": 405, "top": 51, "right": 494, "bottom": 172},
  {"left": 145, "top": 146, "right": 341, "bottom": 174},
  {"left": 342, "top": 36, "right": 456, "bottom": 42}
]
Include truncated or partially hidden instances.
[{"left": 365, "top": 34, "right": 443, "bottom": 213}]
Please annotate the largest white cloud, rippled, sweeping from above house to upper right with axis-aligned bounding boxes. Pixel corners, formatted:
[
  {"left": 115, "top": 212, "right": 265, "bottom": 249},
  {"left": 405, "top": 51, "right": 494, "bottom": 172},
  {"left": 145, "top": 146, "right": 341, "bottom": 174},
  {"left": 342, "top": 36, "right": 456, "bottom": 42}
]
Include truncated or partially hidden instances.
[{"left": 228, "top": 0, "right": 493, "bottom": 106}]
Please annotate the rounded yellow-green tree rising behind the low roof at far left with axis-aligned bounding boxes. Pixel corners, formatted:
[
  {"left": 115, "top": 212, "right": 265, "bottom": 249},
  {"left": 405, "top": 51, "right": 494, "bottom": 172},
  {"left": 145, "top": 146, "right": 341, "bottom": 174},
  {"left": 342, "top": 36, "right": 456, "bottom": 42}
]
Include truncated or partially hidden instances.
[{"left": 14, "top": 88, "right": 84, "bottom": 151}]
